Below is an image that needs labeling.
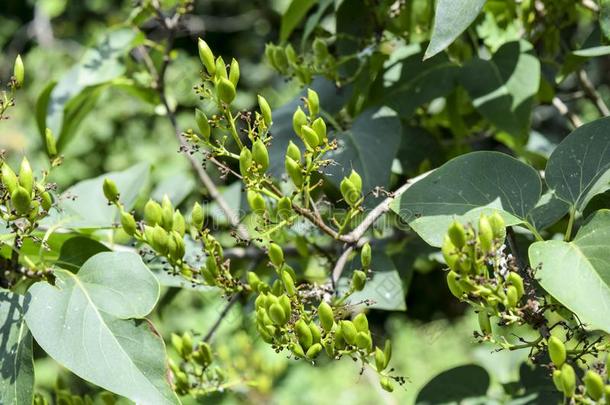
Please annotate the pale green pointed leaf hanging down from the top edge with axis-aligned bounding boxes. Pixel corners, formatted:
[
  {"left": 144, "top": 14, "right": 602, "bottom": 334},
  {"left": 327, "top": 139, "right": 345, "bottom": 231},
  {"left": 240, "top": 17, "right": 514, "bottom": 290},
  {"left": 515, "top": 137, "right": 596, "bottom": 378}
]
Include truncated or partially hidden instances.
[{"left": 424, "top": 0, "right": 485, "bottom": 59}]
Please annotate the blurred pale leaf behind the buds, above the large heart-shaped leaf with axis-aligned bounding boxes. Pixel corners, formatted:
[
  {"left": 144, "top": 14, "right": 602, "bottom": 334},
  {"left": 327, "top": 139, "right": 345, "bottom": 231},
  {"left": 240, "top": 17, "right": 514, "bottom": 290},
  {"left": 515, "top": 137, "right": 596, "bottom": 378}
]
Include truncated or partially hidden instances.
[{"left": 46, "top": 163, "right": 149, "bottom": 228}]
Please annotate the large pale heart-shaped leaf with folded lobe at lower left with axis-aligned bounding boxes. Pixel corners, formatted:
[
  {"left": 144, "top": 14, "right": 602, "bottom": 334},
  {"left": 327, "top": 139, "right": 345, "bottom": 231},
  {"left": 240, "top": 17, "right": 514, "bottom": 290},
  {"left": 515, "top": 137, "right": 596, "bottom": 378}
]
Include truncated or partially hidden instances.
[{"left": 25, "top": 252, "right": 178, "bottom": 404}]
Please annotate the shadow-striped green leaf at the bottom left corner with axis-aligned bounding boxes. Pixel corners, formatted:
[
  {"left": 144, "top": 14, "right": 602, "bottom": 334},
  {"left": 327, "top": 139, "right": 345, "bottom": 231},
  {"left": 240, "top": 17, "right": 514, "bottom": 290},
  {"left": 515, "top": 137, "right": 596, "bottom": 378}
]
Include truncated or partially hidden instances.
[{"left": 0, "top": 290, "right": 34, "bottom": 404}]
